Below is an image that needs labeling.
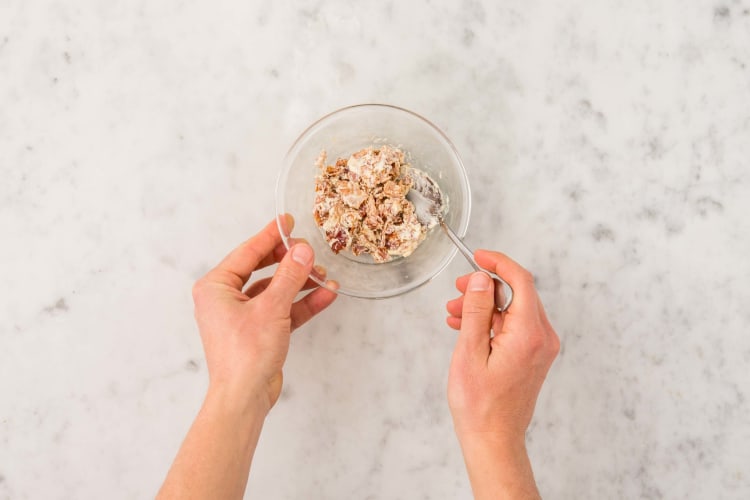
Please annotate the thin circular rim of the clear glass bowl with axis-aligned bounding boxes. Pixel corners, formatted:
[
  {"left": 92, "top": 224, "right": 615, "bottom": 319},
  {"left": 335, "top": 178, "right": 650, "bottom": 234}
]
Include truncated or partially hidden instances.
[{"left": 275, "top": 102, "right": 471, "bottom": 300}]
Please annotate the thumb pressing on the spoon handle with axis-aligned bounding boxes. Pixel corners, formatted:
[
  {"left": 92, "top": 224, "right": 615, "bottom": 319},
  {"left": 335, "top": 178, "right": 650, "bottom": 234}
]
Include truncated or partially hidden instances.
[{"left": 458, "top": 271, "right": 495, "bottom": 359}]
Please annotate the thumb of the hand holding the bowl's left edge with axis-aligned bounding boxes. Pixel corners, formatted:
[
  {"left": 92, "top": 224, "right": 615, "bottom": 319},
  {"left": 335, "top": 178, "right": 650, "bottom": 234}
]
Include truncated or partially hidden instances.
[{"left": 263, "top": 243, "right": 314, "bottom": 312}]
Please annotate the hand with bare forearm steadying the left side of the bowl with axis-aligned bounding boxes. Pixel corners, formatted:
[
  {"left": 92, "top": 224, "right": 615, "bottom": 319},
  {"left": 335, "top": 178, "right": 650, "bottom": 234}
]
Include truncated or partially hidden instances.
[{"left": 158, "top": 216, "right": 336, "bottom": 499}]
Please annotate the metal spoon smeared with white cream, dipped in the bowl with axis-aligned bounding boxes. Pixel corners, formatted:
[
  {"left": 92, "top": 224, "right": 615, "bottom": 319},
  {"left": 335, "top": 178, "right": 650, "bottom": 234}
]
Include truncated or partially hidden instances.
[{"left": 406, "top": 168, "right": 513, "bottom": 312}]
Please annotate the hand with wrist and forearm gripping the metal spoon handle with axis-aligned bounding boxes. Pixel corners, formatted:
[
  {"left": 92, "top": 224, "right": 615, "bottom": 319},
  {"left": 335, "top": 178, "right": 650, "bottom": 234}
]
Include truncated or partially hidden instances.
[{"left": 447, "top": 250, "right": 560, "bottom": 498}]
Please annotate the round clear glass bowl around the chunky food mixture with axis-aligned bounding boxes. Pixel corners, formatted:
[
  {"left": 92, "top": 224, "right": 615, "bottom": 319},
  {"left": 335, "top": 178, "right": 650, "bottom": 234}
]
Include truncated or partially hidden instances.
[{"left": 276, "top": 104, "right": 471, "bottom": 299}]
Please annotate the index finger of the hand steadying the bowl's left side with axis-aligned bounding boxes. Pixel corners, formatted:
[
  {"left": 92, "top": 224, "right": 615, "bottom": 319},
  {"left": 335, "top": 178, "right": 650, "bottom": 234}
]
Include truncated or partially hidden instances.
[{"left": 207, "top": 215, "right": 294, "bottom": 290}]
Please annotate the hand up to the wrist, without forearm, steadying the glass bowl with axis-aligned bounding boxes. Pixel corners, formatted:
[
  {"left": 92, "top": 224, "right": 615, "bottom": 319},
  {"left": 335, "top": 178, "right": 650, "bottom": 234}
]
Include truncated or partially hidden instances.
[{"left": 193, "top": 216, "right": 336, "bottom": 413}]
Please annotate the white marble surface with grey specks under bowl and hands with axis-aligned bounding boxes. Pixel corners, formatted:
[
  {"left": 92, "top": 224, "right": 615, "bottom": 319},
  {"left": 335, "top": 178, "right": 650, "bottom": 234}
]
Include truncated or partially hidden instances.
[{"left": 0, "top": 0, "right": 750, "bottom": 499}]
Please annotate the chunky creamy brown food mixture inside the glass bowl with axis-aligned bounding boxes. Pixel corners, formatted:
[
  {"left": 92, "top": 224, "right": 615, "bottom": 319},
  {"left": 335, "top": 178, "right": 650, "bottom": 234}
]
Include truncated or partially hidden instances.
[{"left": 313, "top": 146, "right": 440, "bottom": 263}]
